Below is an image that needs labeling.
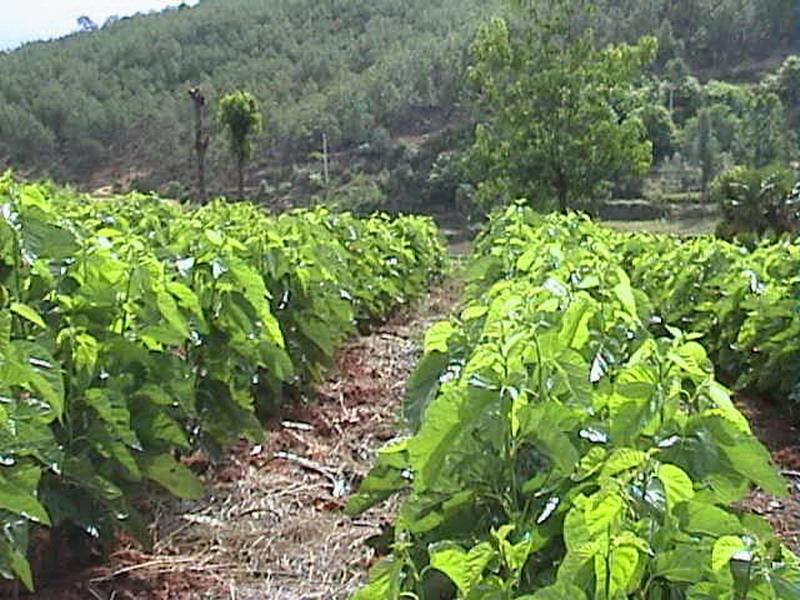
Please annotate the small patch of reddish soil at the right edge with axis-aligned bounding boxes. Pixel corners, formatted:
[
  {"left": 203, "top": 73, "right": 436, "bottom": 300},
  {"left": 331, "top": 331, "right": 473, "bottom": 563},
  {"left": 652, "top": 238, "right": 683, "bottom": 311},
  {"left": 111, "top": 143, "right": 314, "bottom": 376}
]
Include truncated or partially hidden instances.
[{"left": 736, "top": 396, "right": 800, "bottom": 553}]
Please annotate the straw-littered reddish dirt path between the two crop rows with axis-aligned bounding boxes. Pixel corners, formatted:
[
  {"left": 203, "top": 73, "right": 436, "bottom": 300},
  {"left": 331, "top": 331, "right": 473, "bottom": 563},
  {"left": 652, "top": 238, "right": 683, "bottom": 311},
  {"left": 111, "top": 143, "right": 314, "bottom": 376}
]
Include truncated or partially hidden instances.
[{"left": 28, "top": 282, "right": 460, "bottom": 600}]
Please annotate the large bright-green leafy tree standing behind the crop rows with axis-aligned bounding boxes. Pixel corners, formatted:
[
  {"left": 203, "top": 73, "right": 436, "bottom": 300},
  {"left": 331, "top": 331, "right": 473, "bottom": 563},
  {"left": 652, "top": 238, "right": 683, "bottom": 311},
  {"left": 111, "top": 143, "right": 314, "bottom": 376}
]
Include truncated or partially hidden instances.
[{"left": 468, "top": 0, "right": 656, "bottom": 211}]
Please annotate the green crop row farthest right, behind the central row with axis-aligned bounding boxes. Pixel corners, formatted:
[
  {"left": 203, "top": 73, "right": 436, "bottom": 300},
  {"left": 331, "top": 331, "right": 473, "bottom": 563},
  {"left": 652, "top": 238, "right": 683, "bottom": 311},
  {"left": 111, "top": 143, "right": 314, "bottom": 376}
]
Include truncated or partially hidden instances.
[{"left": 618, "top": 230, "right": 800, "bottom": 402}]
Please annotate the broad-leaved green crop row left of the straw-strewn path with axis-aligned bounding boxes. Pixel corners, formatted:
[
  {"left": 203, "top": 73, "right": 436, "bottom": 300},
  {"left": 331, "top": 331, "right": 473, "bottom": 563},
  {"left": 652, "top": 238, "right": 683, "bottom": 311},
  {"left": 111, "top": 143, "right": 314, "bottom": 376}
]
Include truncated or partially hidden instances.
[{"left": 0, "top": 176, "right": 443, "bottom": 588}]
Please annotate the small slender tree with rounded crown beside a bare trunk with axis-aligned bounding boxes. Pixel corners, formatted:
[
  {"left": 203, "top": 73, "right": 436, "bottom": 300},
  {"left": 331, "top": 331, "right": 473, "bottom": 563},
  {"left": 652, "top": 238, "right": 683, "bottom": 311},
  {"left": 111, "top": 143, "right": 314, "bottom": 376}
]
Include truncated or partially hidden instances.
[{"left": 219, "top": 90, "right": 263, "bottom": 198}]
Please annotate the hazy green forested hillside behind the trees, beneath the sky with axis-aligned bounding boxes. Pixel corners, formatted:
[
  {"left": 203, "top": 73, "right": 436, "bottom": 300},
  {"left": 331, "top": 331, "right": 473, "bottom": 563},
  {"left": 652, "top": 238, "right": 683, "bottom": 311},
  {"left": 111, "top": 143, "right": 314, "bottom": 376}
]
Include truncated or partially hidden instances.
[{"left": 0, "top": 0, "right": 797, "bottom": 199}]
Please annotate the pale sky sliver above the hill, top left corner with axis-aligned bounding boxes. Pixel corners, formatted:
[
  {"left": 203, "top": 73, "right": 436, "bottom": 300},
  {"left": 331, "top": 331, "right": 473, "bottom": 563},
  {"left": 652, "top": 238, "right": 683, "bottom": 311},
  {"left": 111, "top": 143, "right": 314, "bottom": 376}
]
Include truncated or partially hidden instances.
[{"left": 0, "top": 0, "right": 197, "bottom": 50}]
